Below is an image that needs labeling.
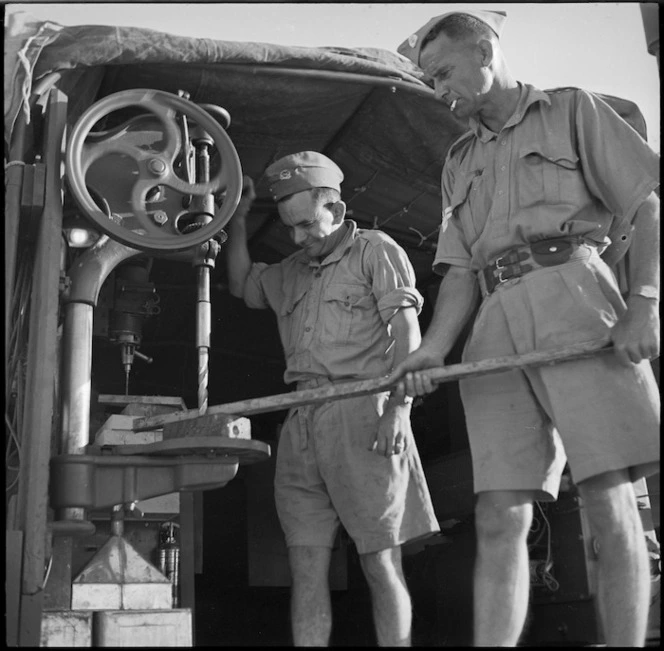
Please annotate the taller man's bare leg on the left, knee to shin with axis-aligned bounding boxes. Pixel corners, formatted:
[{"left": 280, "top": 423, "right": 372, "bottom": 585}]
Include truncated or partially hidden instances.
[{"left": 473, "top": 491, "right": 533, "bottom": 646}]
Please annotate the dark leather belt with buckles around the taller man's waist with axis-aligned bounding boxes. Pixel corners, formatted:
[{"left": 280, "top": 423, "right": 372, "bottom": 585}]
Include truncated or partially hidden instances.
[{"left": 478, "top": 237, "right": 590, "bottom": 296}]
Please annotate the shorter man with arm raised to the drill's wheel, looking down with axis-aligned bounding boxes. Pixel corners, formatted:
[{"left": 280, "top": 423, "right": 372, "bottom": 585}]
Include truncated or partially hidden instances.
[{"left": 226, "top": 152, "right": 438, "bottom": 646}]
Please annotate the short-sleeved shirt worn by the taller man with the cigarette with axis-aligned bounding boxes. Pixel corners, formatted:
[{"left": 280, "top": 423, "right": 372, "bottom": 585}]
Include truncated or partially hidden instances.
[{"left": 434, "top": 84, "right": 659, "bottom": 273}]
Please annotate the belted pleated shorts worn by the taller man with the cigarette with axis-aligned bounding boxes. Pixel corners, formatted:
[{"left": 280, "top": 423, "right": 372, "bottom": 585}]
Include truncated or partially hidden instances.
[{"left": 459, "top": 249, "right": 660, "bottom": 500}]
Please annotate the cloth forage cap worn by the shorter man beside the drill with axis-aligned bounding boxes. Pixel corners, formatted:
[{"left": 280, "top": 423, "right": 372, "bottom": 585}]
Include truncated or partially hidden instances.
[{"left": 265, "top": 151, "right": 344, "bottom": 201}]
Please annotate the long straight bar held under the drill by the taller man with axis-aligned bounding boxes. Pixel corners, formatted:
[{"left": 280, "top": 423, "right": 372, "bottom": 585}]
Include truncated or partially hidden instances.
[{"left": 133, "top": 341, "right": 613, "bottom": 432}]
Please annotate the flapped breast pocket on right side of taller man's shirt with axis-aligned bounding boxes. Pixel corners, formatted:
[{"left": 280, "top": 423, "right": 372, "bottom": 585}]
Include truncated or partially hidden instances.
[{"left": 517, "top": 142, "right": 584, "bottom": 208}]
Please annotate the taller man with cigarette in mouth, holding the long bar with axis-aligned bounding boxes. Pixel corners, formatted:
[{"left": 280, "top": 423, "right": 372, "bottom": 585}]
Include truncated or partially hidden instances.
[{"left": 393, "top": 10, "right": 659, "bottom": 646}]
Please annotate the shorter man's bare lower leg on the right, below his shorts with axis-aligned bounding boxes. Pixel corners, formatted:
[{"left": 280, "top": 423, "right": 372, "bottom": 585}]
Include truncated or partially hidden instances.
[{"left": 360, "top": 547, "right": 413, "bottom": 646}]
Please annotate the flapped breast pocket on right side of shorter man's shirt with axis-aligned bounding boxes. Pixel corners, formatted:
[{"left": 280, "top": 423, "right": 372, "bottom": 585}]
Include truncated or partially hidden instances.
[{"left": 319, "top": 283, "right": 375, "bottom": 346}]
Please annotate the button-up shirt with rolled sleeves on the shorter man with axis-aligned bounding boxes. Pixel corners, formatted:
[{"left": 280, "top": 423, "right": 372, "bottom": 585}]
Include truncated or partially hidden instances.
[{"left": 244, "top": 220, "right": 423, "bottom": 383}]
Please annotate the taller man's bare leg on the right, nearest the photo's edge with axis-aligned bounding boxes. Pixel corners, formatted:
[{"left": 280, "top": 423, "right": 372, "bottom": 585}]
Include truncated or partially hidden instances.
[{"left": 579, "top": 470, "right": 650, "bottom": 647}]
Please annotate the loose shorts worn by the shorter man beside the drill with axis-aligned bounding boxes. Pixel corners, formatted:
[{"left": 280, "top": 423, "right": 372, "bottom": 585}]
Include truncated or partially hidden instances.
[{"left": 274, "top": 393, "right": 439, "bottom": 554}]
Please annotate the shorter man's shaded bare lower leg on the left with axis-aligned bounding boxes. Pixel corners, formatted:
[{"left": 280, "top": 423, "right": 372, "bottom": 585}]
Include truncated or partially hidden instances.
[{"left": 288, "top": 547, "right": 332, "bottom": 646}]
